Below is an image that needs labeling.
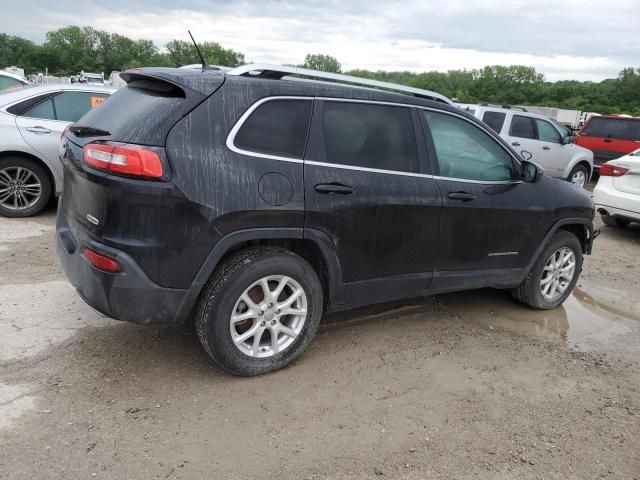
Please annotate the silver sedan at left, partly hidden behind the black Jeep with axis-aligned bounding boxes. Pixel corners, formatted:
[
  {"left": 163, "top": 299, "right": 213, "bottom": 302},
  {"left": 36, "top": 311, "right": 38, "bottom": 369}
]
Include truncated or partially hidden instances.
[{"left": 0, "top": 84, "right": 113, "bottom": 217}]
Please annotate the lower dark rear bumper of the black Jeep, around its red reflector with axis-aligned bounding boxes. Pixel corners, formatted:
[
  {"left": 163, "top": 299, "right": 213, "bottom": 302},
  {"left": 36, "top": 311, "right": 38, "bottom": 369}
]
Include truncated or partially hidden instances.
[{"left": 56, "top": 204, "right": 196, "bottom": 324}]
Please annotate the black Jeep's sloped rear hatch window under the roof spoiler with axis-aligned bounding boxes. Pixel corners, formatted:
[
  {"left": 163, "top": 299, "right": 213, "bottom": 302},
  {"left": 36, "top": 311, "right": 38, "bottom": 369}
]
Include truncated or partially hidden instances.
[{"left": 76, "top": 79, "right": 195, "bottom": 146}]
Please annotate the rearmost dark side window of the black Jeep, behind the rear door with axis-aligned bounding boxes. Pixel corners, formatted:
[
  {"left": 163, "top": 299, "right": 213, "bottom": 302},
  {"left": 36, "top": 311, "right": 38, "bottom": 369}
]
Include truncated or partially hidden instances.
[{"left": 233, "top": 99, "right": 312, "bottom": 158}]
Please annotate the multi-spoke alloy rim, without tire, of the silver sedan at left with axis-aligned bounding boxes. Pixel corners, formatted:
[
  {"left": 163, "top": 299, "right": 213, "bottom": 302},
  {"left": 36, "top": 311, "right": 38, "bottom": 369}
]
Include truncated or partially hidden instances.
[{"left": 0, "top": 167, "right": 42, "bottom": 210}]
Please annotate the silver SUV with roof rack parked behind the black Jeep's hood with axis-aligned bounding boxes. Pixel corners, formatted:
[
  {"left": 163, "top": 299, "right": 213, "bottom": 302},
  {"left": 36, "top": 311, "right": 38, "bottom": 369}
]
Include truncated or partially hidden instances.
[{"left": 462, "top": 105, "right": 593, "bottom": 187}]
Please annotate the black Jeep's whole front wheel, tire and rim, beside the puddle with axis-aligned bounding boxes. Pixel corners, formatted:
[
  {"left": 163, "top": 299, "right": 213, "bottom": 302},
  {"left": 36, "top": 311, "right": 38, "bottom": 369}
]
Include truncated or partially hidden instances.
[{"left": 511, "top": 230, "right": 582, "bottom": 310}]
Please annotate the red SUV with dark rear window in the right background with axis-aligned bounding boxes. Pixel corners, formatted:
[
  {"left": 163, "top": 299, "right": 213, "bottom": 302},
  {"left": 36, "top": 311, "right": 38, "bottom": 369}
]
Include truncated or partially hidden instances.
[{"left": 576, "top": 115, "right": 640, "bottom": 168}]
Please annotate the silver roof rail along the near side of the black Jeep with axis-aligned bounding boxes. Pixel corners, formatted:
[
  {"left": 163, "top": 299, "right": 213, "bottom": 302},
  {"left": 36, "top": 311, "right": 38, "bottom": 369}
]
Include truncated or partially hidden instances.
[{"left": 226, "top": 63, "right": 453, "bottom": 105}]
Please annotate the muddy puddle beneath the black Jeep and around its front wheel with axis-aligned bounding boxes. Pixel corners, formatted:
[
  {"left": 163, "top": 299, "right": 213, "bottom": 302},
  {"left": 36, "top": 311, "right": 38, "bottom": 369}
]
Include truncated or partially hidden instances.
[{"left": 323, "top": 288, "right": 640, "bottom": 358}]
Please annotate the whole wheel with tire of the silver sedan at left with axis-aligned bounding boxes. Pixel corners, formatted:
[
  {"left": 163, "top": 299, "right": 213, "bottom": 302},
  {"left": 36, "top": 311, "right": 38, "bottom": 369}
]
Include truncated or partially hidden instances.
[{"left": 0, "top": 157, "right": 53, "bottom": 218}]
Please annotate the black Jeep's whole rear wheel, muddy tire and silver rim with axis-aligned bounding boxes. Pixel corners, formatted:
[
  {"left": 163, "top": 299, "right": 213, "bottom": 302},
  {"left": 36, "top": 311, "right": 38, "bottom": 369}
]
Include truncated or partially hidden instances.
[{"left": 196, "top": 247, "right": 323, "bottom": 376}]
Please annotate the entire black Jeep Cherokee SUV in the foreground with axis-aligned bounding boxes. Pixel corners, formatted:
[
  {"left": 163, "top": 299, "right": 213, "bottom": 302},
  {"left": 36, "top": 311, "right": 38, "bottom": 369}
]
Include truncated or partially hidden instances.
[{"left": 57, "top": 66, "right": 594, "bottom": 375}]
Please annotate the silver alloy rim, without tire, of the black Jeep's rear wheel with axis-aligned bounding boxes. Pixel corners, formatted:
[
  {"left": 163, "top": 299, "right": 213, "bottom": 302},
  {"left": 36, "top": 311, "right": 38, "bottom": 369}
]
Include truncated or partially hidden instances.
[{"left": 229, "top": 275, "right": 307, "bottom": 358}]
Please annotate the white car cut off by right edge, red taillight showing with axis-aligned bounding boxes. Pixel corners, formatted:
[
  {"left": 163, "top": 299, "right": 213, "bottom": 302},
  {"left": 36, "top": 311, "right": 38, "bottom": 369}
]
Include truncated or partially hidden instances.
[{"left": 593, "top": 149, "right": 640, "bottom": 227}]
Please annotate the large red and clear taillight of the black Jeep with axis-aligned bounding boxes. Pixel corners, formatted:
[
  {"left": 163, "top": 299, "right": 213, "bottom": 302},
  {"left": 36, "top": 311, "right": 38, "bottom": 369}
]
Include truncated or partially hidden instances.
[{"left": 83, "top": 143, "right": 164, "bottom": 178}]
